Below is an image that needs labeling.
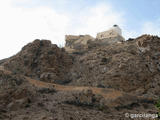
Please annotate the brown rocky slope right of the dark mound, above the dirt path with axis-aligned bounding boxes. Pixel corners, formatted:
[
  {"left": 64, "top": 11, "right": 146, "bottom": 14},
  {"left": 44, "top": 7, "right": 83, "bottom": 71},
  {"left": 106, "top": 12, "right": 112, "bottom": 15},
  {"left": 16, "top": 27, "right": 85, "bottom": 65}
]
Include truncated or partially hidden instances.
[{"left": 69, "top": 35, "right": 160, "bottom": 92}]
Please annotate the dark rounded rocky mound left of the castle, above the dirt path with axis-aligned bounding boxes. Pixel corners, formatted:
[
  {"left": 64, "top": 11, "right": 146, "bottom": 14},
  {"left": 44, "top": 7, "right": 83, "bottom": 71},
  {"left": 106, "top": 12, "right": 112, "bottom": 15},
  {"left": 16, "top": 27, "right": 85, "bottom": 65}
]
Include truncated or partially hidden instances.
[{"left": 2, "top": 40, "right": 72, "bottom": 84}]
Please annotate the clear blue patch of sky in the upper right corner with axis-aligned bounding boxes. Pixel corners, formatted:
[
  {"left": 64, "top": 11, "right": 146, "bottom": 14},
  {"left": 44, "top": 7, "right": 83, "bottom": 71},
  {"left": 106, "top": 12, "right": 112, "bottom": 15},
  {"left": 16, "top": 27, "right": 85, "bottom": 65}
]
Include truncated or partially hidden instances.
[{"left": 109, "top": 0, "right": 160, "bottom": 30}]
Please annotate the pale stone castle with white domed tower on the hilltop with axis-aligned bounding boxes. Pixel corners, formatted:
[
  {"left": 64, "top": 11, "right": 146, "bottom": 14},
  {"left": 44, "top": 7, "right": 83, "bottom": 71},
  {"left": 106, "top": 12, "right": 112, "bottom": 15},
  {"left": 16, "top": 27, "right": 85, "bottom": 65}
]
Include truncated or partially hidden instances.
[{"left": 65, "top": 25, "right": 125, "bottom": 52}]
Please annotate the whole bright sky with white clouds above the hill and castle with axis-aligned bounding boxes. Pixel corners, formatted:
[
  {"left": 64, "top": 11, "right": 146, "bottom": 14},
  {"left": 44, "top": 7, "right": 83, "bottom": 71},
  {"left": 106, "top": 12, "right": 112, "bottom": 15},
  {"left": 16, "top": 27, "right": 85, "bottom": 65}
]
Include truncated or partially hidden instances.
[{"left": 0, "top": 0, "right": 160, "bottom": 59}]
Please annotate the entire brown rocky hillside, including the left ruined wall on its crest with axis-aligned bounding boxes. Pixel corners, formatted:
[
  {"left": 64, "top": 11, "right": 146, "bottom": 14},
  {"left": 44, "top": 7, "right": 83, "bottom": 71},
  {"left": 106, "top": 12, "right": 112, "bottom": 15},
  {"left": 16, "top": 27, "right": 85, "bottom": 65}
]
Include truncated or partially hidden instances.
[{"left": 0, "top": 35, "right": 160, "bottom": 120}]
